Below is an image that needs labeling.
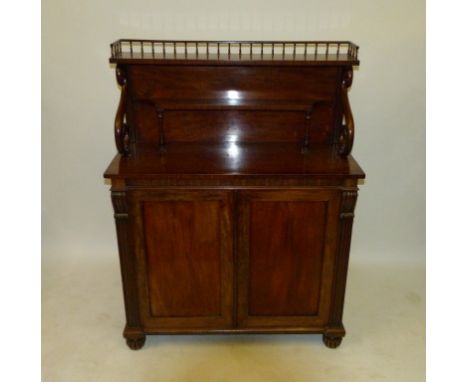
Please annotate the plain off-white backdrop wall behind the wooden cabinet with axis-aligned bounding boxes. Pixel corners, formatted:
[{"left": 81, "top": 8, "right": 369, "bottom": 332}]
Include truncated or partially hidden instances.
[{"left": 42, "top": 0, "right": 425, "bottom": 262}]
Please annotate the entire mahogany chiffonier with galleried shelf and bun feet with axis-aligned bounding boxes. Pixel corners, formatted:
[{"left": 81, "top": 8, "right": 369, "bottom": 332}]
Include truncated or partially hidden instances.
[{"left": 104, "top": 40, "right": 365, "bottom": 349}]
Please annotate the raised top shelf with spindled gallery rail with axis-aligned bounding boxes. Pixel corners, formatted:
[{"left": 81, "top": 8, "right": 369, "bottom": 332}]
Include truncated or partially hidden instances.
[{"left": 109, "top": 39, "right": 359, "bottom": 66}]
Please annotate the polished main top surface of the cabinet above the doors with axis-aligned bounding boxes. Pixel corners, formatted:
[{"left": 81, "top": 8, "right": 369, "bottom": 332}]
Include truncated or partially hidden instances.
[{"left": 104, "top": 142, "right": 365, "bottom": 178}]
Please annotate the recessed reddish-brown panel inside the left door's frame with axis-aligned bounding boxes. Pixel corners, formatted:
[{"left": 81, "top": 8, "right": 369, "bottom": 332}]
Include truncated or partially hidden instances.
[{"left": 141, "top": 200, "right": 222, "bottom": 317}]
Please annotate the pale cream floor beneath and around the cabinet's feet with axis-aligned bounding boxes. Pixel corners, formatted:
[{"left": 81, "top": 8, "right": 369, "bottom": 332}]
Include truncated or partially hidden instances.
[{"left": 42, "top": 256, "right": 425, "bottom": 382}]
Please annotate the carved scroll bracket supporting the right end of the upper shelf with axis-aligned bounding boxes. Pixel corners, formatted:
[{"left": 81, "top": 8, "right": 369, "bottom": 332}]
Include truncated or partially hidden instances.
[{"left": 338, "top": 67, "right": 354, "bottom": 156}]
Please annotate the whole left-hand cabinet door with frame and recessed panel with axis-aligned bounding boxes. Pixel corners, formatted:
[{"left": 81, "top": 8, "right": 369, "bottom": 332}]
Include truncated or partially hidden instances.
[{"left": 129, "top": 190, "right": 233, "bottom": 332}]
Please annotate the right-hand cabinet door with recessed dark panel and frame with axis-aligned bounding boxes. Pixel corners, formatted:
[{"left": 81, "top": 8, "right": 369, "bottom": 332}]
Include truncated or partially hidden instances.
[{"left": 237, "top": 189, "right": 340, "bottom": 330}]
